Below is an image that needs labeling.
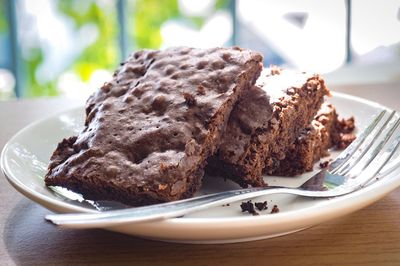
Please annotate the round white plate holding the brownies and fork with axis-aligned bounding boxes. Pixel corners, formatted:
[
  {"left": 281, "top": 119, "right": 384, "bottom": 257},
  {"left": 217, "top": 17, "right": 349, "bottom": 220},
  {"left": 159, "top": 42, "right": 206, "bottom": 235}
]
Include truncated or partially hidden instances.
[{"left": 1, "top": 93, "right": 400, "bottom": 243}]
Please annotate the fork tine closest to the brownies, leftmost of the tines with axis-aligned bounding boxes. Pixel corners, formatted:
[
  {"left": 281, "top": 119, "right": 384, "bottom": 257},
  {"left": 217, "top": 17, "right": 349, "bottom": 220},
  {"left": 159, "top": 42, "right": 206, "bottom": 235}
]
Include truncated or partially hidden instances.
[{"left": 329, "top": 110, "right": 386, "bottom": 174}]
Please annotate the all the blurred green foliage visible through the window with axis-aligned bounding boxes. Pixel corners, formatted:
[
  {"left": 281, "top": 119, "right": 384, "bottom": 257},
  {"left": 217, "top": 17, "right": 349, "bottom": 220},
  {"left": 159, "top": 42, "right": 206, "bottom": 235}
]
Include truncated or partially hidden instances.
[{"left": 0, "top": 0, "right": 229, "bottom": 97}]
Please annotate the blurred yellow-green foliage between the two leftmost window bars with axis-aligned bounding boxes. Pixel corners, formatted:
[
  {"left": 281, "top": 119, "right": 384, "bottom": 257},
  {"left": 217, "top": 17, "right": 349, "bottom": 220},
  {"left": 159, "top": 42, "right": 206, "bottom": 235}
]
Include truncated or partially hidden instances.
[{"left": 24, "top": 0, "right": 119, "bottom": 97}]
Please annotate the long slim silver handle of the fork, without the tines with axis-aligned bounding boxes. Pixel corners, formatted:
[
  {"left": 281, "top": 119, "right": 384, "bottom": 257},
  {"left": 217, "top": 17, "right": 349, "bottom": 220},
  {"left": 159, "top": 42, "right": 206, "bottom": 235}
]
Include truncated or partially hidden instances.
[{"left": 45, "top": 186, "right": 304, "bottom": 228}]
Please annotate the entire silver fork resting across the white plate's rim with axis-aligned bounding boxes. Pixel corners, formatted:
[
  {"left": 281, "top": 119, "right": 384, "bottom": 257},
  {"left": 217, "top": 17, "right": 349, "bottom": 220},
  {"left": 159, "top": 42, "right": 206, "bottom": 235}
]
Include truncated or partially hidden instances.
[{"left": 45, "top": 108, "right": 400, "bottom": 228}]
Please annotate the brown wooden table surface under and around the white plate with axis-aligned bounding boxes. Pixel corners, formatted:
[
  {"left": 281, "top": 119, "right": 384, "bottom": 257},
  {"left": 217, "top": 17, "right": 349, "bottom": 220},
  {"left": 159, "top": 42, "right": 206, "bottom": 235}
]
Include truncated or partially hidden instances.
[{"left": 0, "top": 83, "right": 400, "bottom": 265}]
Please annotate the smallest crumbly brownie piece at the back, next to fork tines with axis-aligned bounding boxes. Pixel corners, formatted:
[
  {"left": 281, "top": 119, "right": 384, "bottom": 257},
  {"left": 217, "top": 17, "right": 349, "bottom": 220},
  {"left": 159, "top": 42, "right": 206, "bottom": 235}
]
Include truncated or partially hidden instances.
[{"left": 272, "top": 103, "right": 355, "bottom": 176}]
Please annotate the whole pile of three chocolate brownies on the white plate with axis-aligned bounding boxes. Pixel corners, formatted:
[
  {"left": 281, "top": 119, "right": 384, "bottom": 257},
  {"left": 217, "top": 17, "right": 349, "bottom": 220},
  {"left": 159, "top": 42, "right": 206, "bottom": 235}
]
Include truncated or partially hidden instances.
[{"left": 45, "top": 47, "right": 354, "bottom": 206}]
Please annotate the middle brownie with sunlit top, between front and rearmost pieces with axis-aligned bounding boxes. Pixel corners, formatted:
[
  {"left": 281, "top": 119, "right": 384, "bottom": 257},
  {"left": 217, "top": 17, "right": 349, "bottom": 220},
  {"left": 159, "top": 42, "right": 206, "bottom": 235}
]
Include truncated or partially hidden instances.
[{"left": 207, "top": 66, "right": 329, "bottom": 187}]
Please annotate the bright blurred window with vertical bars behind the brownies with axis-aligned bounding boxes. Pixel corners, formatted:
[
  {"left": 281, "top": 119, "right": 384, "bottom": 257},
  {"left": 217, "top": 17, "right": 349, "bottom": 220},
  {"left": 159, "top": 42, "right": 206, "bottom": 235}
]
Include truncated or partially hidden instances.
[{"left": 0, "top": 0, "right": 400, "bottom": 100}]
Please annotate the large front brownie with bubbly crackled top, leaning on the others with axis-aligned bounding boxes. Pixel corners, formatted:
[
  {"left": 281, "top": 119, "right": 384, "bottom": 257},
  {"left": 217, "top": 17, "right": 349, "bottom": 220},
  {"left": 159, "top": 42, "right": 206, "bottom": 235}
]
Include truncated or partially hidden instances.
[{"left": 45, "top": 47, "right": 262, "bottom": 206}]
